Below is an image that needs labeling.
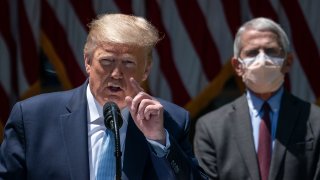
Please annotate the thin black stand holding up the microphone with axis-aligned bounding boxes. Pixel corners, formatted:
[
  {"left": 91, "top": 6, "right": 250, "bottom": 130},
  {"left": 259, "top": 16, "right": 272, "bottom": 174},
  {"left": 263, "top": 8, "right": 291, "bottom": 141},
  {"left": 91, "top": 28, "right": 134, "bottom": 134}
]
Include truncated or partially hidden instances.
[{"left": 112, "top": 111, "right": 122, "bottom": 180}]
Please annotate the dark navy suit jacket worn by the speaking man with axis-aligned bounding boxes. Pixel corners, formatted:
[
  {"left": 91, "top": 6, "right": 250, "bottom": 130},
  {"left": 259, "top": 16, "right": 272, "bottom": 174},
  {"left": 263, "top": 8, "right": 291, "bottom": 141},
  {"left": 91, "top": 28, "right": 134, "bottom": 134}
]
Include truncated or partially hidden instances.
[{"left": 0, "top": 82, "right": 202, "bottom": 180}]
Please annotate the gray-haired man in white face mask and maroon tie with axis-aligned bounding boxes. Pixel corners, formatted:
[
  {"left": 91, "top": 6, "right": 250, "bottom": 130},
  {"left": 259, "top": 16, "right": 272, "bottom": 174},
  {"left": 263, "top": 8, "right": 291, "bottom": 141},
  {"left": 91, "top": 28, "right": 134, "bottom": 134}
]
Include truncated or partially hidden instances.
[{"left": 194, "top": 18, "right": 320, "bottom": 180}]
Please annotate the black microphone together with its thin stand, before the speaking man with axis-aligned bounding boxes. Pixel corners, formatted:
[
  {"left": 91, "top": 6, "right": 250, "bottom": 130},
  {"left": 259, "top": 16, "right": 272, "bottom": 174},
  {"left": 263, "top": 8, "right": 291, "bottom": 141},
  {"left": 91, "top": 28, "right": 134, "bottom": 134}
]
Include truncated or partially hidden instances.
[{"left": 103, "top": 101, "right": 123, "bottom": 180}]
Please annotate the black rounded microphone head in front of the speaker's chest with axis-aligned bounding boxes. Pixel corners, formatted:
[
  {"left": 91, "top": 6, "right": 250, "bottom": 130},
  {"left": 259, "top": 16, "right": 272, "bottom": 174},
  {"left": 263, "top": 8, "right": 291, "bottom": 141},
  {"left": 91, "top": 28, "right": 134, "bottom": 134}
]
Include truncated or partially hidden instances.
[{"left": 103, "top": 101, "right": 123, "bottom": 131}]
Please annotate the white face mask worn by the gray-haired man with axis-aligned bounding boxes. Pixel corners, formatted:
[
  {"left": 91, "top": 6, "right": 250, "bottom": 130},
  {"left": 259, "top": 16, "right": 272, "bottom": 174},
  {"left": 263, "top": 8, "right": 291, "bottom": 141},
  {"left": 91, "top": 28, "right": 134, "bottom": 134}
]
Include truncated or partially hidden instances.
[{"left": 238, "top": 53, "right": 284, "bottom": 93}]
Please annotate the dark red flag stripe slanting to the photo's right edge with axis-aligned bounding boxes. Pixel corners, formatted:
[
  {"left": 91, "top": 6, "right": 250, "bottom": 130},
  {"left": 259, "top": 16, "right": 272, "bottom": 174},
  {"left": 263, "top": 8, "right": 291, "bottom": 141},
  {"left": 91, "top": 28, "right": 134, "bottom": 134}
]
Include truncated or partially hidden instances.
[{"left": 281, "top": 0, "right": 320, "bottom": 97}]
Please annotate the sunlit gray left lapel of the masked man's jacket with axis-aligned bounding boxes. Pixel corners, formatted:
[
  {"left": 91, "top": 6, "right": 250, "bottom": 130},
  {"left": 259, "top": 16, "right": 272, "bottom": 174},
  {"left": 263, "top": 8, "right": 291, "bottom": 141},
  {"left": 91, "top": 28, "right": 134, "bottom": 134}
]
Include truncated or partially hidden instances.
[{"left": 230, "top": 95, "right": 260, "bottom": 179}]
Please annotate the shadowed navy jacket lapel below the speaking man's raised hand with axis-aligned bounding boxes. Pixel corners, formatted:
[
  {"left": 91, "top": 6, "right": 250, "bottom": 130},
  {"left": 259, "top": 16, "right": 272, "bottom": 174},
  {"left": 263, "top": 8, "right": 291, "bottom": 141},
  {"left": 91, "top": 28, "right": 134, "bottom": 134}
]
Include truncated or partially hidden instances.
[{"left": 122, "top": 115, "right": 150, "bottom": 179}]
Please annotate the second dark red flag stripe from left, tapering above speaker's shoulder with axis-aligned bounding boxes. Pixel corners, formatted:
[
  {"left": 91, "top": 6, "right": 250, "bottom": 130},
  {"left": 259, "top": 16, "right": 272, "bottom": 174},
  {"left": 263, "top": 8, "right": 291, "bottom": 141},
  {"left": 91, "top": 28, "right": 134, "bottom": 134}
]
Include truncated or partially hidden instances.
[{"left": 18, "top": 1, "right": 40, "bottom": 85}]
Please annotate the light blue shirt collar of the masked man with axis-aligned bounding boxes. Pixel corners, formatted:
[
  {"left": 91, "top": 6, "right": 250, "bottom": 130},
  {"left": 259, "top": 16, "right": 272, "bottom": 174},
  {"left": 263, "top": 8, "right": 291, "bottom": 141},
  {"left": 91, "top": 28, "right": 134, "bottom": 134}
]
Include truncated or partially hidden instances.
[{"left": 247, "top": 86, "right": 284, "bottom": 116}]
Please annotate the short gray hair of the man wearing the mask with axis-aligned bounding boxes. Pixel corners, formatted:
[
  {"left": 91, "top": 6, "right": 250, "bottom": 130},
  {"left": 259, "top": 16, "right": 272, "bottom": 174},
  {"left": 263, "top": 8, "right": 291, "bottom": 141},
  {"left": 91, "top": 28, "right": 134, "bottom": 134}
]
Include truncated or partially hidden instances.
[{"left": 233, "top": 17, "right": 290, "bottom": 57}]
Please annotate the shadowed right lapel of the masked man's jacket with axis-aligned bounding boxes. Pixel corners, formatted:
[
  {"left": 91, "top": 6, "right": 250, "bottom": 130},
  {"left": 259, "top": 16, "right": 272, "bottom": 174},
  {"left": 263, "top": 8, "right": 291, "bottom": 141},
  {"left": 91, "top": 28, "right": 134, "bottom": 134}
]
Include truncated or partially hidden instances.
[{"left": 269, "top": 92, "right": 300, "bottom": 179}]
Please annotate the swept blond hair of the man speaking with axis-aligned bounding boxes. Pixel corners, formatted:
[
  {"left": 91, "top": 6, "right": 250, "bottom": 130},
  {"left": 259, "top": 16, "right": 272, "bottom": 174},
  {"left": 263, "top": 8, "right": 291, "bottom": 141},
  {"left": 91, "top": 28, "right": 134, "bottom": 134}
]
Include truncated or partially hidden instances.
[{"left": 84, "top": 14, "right": 161, "bottom": 59}]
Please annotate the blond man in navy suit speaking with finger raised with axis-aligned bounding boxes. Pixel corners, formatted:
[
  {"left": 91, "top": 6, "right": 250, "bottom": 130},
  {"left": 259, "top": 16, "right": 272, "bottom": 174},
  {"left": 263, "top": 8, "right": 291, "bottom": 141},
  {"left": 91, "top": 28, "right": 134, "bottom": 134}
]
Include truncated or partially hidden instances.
[{"left": 0, "top": 14, "right": 205, "bottom": 180}]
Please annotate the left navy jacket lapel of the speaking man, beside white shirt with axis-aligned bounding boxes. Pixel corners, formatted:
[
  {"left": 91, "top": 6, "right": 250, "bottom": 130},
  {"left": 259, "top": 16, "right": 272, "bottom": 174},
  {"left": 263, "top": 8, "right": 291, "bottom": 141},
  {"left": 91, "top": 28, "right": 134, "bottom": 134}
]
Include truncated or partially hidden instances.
[{"left": 60, "top": 83, "right": 90, "bottom": 179}]
